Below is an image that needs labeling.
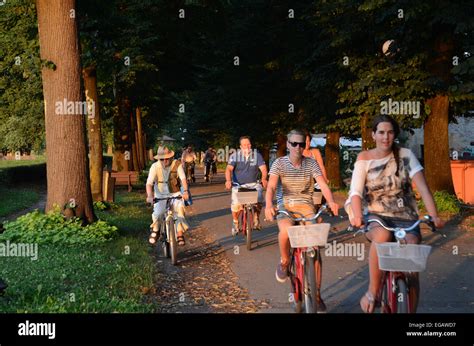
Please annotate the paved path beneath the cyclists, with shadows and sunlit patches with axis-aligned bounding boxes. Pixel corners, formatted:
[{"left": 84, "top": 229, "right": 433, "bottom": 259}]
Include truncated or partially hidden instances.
[{"left": 191, "top": 171, "right": 474, "bottom": 313}]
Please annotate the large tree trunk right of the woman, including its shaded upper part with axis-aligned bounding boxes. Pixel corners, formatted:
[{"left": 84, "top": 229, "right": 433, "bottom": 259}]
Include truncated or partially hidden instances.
[{"left": 423, "top": 25, "right": 454, "bottom": 193}]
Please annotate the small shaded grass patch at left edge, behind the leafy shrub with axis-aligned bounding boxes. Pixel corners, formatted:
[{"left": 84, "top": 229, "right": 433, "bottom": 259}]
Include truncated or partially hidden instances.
[{"left": 0, "top": 186, "right": 40, "bottom": 218}]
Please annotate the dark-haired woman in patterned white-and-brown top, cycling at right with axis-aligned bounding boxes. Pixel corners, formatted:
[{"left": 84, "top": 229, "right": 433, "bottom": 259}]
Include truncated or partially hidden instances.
[{"left": 348, "top": 115, "right": 444, "bottom": 313}]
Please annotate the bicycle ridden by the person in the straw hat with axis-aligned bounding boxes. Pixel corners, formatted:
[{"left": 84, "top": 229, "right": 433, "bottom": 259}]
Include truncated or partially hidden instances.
[{"left": 150, "top": 196, "right": 182, "bottom": 265}]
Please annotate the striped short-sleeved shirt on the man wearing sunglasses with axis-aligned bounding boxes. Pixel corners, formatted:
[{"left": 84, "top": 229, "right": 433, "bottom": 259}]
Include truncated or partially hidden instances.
[{"left": 269, "top": 156, "right": 322, "bottom": 207}]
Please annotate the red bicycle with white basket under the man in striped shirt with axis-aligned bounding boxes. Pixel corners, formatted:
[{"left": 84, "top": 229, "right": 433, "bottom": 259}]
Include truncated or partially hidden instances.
[{"left": 277, "top": 204, "right": 332, "bottom": 313}]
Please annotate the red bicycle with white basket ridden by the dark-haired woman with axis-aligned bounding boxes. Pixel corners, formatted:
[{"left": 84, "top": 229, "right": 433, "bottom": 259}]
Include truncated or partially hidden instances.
[{"left": 354, "top": 215, "right": 436, "bottom": 313}]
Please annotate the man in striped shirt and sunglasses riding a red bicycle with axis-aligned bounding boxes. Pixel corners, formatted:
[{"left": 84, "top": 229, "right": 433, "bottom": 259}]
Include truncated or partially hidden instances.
[{"left": 265, "top": 130, "right": 339, "bottom": 312}]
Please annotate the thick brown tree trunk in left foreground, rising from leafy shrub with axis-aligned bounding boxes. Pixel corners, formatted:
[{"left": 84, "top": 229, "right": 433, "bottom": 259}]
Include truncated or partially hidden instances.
[{"left": 36, "top": 0, "right": 96, "bottom": 222}]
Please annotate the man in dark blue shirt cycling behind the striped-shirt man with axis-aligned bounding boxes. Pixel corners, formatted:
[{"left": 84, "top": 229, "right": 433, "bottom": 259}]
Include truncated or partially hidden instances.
[{"left": 225, "top": 136, "right": 267, "bottom": 234}]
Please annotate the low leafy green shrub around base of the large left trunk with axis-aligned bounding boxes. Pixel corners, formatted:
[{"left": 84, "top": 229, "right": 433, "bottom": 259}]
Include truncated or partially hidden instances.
[{"left": 0, "top": 207, "right": 117, "bottom": 244}]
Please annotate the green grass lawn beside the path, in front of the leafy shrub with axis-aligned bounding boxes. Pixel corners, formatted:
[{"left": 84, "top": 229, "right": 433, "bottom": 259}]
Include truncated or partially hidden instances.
[{"left": 0, "top": 191, "right": 156, "bottom": 313}]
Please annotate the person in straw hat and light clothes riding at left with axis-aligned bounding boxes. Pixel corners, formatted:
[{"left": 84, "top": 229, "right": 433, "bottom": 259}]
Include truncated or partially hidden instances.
[{"left": 146, "top": 147, "right": 189, "bottom": 246}]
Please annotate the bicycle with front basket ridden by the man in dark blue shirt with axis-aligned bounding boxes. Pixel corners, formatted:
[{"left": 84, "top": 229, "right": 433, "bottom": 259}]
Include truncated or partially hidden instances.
[{"left": 232, "top": 182, "right": 258, "bottom": 251}]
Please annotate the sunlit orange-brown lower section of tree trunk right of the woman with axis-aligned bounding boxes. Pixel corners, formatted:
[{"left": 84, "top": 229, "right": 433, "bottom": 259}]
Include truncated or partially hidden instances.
[{"left": 423, "top": 95, "right": 454, "bottom": 193}]
